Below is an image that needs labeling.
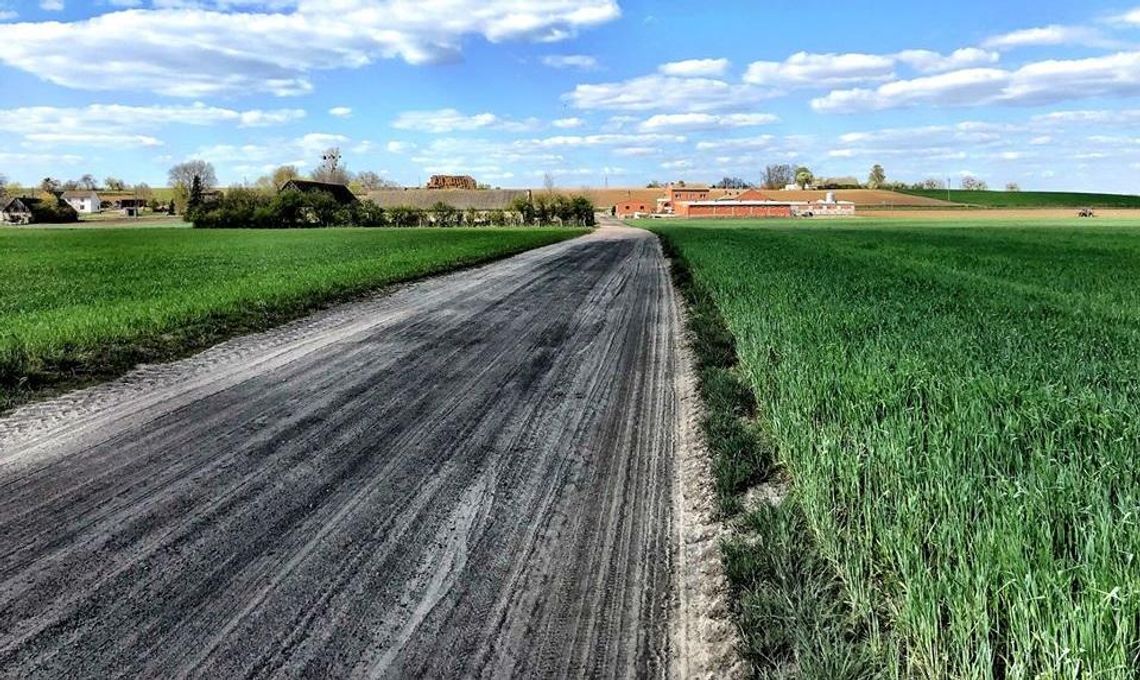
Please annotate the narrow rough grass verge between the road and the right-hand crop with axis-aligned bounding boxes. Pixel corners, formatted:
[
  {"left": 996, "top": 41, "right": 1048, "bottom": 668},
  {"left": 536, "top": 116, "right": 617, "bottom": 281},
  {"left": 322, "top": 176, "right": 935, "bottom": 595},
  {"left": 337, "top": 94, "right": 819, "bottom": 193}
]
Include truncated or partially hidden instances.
[{"left": 658, "top": 234, "right": 880, "bottom": 679}]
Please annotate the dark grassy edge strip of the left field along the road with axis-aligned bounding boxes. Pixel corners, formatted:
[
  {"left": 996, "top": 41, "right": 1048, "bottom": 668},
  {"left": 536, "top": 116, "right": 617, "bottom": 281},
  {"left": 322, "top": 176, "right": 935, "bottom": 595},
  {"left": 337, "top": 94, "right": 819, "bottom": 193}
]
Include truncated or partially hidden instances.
[{"left": 0, "top": 229, "right": 583, "bottom": 415}]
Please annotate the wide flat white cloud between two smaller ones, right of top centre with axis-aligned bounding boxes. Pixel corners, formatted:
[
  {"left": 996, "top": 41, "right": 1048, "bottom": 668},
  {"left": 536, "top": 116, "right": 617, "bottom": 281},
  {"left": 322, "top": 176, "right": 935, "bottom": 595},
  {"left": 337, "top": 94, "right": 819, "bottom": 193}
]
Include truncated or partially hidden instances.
[{"left": 562, "top": 74, "right": 771, "bottom": 113}]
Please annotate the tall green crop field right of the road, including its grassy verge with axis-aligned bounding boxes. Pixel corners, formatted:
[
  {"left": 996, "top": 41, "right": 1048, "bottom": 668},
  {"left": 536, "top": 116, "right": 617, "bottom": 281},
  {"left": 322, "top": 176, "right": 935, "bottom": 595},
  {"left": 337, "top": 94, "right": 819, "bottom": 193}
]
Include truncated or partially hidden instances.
[{"left": 653, "top": 220, "right": 1140, "bottom": 678}]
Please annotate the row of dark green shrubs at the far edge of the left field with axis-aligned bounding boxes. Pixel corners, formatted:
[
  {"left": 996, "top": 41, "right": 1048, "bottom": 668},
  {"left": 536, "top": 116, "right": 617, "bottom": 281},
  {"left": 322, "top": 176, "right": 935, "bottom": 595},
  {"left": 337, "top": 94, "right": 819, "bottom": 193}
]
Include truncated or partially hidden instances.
[{"left": 186, "top": 188, "right": 594, "bottom": 229}]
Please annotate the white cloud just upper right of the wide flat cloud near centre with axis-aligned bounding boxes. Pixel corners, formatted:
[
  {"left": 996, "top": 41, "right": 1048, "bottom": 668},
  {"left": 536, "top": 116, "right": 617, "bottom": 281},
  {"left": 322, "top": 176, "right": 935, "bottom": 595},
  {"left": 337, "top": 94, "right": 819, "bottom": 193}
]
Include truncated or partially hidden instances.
[{"left": 744, "top": 52, "right": 895, "bottom": 88}]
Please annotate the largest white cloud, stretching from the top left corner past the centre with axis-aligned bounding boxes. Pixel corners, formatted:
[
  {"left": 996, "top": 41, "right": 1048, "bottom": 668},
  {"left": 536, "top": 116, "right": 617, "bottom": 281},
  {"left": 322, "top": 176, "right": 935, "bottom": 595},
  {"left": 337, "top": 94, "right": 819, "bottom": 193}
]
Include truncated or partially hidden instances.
[{"left": 0, "top": 0, "right": 620, "bottom": 97}]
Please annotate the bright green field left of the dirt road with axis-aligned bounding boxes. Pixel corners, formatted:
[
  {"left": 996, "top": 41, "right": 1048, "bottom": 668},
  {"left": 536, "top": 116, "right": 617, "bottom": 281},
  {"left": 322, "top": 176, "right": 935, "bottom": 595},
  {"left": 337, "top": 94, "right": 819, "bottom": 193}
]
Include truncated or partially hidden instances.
[{"left": 0, "top": 228, "right": 583, "bottom": 411}]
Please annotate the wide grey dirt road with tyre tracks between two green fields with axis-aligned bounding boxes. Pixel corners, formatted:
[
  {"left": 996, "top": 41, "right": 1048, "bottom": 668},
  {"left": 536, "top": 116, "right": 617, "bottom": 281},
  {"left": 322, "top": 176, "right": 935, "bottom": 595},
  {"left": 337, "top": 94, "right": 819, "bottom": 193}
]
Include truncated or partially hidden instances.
[{"left": 0, "top": 221, "right": 720, "bottom": 678}]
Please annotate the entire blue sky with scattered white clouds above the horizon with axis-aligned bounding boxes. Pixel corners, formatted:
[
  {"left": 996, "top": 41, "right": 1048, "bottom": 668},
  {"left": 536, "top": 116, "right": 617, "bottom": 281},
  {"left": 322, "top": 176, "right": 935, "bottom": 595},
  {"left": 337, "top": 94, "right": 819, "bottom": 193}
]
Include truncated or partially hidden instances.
[{"left": 0, "top": 0, "right": 1140, "bottom": 193}]
